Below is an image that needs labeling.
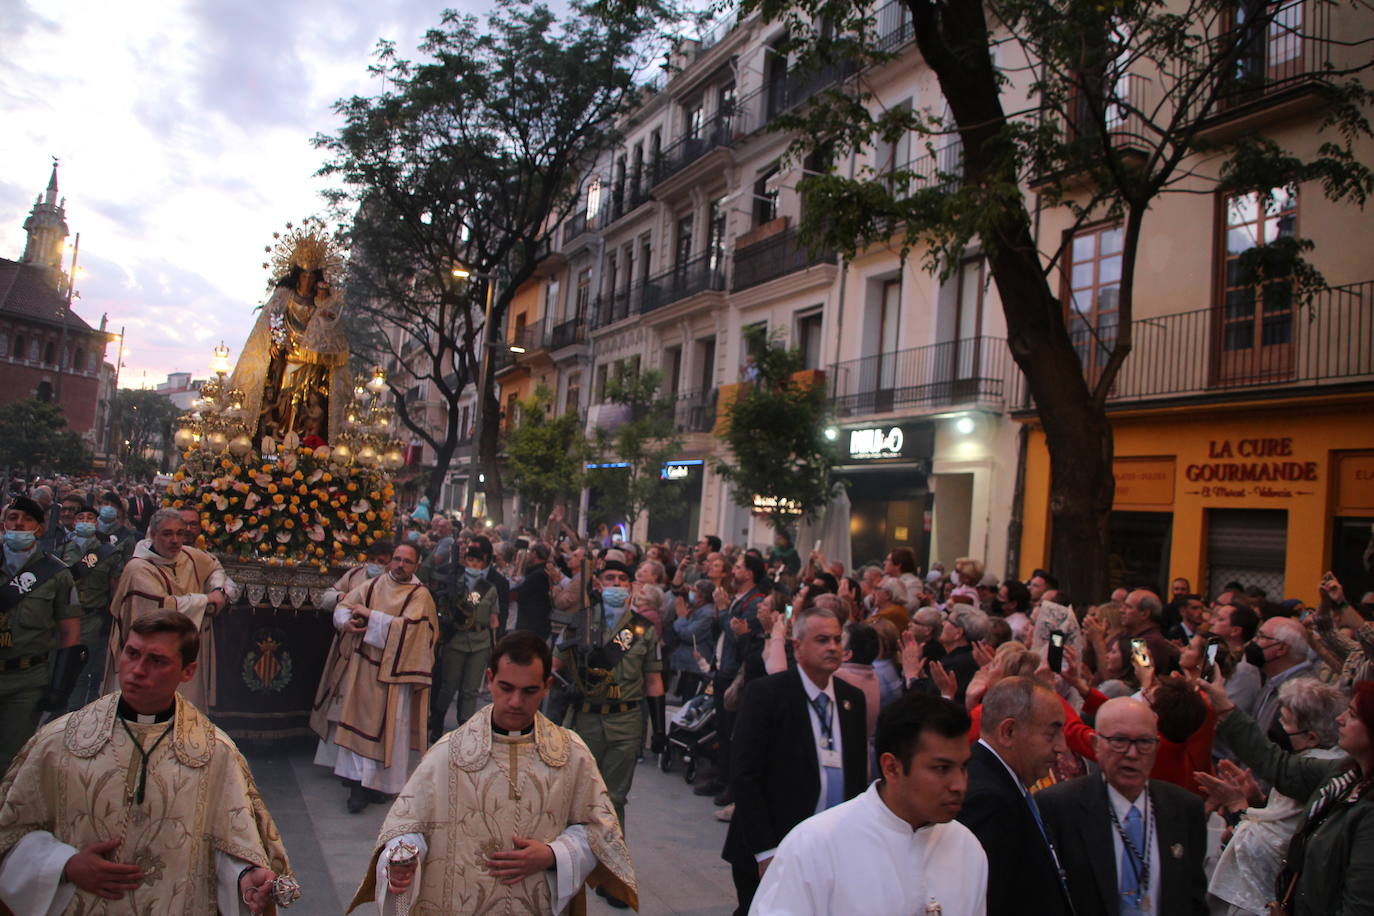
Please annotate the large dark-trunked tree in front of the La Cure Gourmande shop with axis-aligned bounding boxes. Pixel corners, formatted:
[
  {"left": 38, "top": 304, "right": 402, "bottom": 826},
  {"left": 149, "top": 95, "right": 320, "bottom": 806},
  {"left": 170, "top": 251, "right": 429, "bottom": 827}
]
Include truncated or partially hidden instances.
[{"left": 743, "top": 0, "right": 1374, "bottom": 596}]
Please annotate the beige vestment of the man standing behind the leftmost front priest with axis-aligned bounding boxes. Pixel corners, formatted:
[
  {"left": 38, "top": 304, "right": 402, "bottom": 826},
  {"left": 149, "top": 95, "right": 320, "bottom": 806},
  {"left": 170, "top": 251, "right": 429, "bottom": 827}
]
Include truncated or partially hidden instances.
[{"left": 102, "top": 538, "right": 239, "bottom": 713}]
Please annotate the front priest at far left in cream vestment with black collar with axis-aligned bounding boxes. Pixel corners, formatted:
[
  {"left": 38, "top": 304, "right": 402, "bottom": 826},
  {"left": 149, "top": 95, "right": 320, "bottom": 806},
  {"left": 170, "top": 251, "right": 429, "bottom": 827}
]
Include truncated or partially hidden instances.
[{"left": 0, "top": 610, "right": 294, "bottom": 916}]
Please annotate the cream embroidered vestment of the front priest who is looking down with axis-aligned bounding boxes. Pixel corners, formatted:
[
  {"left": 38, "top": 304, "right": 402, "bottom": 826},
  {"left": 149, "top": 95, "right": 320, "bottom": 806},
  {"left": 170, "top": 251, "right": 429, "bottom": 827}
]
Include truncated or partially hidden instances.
[{"left": 350, "top": 706, "right": 639, "bottom": 916}]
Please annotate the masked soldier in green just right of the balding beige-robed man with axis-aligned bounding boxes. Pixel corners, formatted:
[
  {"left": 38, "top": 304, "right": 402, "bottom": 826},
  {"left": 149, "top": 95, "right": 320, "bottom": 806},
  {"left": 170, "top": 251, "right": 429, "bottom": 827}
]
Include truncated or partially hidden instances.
[{"left": 430, "top": 544, "right": 500, "bottom": 742}]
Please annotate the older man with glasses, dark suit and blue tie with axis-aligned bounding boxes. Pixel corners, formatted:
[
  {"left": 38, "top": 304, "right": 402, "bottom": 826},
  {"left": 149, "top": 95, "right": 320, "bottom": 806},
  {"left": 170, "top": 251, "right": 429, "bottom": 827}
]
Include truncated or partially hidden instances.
[{"left": 1037, "top": 696, "right": 1208, "bottom": 916}]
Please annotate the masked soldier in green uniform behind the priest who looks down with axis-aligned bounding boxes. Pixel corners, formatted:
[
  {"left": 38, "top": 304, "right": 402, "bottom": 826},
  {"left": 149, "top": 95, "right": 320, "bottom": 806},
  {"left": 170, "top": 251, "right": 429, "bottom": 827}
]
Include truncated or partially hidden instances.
[{"left": 556, "top": 560, "right": 666, "bottom": 873}]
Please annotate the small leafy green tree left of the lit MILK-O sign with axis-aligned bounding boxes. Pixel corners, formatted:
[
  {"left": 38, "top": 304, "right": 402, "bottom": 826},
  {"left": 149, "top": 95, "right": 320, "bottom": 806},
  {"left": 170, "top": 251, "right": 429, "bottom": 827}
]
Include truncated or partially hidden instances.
[{"left": 716, "top": 327, "right": 835, "bottom": 534}]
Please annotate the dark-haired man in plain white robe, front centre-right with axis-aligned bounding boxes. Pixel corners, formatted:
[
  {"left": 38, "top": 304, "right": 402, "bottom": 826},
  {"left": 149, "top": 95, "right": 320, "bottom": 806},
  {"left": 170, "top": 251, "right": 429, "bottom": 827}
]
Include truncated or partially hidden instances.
[{"left": 749, "top": 694, "right": 988, "bottom": 916}]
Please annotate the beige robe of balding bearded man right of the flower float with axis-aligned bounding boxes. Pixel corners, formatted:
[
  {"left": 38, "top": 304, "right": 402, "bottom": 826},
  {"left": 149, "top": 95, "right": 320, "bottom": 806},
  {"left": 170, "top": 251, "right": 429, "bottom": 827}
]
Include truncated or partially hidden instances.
[{"left": 311, "top": 573, "right": 438, "bottom": 794}]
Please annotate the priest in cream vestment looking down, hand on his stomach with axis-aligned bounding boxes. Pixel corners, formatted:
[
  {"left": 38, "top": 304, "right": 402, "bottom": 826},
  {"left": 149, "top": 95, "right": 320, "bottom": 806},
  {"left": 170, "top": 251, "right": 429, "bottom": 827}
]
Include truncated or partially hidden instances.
[{"left": 352, "top": 630, "right": 638, "bottom": 916}]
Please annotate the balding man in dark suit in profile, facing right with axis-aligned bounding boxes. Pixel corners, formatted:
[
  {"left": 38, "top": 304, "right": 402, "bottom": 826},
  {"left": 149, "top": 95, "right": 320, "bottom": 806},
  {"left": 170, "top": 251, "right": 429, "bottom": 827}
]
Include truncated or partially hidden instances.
[{"left": 959, "top": 677, "right": 1072, "bottom": 916}]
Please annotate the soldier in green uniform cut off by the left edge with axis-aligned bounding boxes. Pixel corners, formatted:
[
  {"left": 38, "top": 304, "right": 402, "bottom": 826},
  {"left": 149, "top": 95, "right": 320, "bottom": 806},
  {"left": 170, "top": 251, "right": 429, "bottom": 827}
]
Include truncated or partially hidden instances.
[{"left": 0, "top": 496, "right": 81, "bottom": 772}]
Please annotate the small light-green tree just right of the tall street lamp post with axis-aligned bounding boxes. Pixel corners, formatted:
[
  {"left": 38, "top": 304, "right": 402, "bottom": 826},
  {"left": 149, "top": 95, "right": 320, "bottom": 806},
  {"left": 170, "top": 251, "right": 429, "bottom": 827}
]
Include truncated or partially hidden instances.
[{"left": 506, "top": 385, "right": 587, "bottom": 526}]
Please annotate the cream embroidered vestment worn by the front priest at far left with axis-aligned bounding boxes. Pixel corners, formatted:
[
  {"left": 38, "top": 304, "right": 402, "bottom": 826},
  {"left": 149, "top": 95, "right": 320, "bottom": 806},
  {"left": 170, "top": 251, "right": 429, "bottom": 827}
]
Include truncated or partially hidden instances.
[{"left": 0, "top": 694, "right": 290, "bottom": 916}]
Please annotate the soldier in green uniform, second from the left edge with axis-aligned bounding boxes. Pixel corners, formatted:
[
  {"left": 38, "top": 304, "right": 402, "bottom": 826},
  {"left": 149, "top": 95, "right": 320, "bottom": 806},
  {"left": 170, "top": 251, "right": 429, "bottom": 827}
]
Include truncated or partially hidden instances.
[{"left": 62, "top": 505, "right": 124, "bottom": 713}]
